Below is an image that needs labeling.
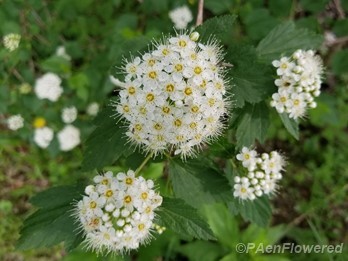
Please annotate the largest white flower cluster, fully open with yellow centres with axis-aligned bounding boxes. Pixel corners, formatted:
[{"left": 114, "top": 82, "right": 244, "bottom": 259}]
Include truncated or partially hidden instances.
[{"left": 113, "top": 33, "right": 227, "bottom": 158}]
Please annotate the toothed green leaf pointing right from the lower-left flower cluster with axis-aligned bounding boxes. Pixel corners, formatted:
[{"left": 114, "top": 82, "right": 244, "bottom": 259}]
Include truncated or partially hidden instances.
[{"left": 158, "top": 198, "right": 215, "bottom": 240}]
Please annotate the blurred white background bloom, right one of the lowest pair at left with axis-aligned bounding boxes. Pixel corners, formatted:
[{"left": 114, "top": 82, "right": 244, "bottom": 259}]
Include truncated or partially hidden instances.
[{"left": 57, "top": 125, "right": 81, "bottom": 151}]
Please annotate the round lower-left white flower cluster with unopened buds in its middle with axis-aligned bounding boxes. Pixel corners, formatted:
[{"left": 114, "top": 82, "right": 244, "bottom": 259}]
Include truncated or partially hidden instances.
[{"left": 74, "top": 170, "right": 162, "bottom": 253}]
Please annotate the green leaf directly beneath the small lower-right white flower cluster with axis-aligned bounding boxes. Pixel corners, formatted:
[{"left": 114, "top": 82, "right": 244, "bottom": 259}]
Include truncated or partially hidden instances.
[{"left": 228, "top": 196, "right": 272, "bottom": 227}]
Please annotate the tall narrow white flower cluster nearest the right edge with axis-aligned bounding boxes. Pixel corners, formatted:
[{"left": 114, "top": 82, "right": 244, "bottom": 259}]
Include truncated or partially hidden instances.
[{"left": 271, "top": 50, "right": 323, "bottom": 119}]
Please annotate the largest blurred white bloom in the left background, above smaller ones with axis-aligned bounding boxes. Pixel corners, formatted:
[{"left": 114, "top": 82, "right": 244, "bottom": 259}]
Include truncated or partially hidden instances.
[{"left": 35, "top": 73, "right": 63, "bottom": 102}]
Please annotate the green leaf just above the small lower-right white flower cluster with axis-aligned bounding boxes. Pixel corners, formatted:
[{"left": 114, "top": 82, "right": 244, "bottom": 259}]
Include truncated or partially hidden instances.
[{"left": 236, "top": 102, "right": 270, "bottom": 148}]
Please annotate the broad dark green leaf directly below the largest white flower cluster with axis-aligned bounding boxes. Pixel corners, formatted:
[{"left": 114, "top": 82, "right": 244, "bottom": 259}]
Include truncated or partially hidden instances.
[{"left": 169, "top": 155, "right": 233, "bottom": 208}]
